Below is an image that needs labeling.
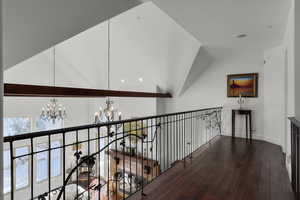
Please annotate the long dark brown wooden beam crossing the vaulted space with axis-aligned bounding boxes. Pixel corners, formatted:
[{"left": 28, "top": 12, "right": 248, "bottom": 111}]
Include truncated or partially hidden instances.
[{"left": 4, "top": 83, "right": 172, "bottom": 98}]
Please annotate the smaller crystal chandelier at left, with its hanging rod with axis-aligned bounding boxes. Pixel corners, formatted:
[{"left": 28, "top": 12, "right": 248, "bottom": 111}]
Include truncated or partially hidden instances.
[{"left": 40, "top": 47, "right": 67, "bottom": 123}]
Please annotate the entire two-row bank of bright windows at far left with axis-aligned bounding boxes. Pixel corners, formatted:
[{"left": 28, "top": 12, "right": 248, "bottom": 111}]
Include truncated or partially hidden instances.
[{"left": 3, "top": 117, "right": 63, "bottom": 193}]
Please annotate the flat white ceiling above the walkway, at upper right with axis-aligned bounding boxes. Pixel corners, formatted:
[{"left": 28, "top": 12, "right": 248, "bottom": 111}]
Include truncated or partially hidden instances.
[{"left": 143, "top": 0, "right": 291, "bottom": 55}]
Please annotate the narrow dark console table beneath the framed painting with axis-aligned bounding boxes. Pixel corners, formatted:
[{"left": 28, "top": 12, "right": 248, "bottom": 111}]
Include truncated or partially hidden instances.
[{"left": 232, "top": 109, "right": 252, "bottom": 142}]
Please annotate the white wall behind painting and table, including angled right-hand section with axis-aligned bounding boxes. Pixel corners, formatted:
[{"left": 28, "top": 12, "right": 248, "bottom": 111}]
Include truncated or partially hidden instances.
[{"left": 166, "top": 47, "right": 286, "bottom": 152}]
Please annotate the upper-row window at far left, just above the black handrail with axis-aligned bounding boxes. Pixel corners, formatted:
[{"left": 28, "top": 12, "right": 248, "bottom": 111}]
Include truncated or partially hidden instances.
[{"left": 3, "top": 117, "right": 31, "bottom": 136}]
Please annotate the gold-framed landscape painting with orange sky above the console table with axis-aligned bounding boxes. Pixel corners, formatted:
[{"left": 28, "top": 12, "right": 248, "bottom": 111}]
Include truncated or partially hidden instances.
[{"left": 227, "top": 73, "right": 258, "bottom": 97}]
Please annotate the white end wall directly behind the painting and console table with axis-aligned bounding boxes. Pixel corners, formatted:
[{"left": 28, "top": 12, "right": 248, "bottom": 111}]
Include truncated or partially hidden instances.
[{"left": 167, "top": 51, "right": 263, "bottom": 139}]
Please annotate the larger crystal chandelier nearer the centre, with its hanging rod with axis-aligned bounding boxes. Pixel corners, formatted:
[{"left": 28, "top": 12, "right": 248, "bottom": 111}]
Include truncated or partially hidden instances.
[{"left": 94, "top": 20, "right": 122, "bottom": 123}]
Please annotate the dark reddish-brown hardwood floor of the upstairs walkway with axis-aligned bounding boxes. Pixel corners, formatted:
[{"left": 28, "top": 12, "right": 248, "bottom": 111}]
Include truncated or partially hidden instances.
[{"left": 129, "top": 136, "right": 294, "bottom": 200}]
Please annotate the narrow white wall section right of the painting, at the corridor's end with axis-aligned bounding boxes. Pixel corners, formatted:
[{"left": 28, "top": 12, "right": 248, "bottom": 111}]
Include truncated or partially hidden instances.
[{"left": 263, "top": 46, "right": 286, "bottom": 147}]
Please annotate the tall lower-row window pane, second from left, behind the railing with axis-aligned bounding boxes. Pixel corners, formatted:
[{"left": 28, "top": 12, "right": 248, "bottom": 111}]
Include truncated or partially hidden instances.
[{"left": 16, "top": 147, "right": 29, "bottom": 189}]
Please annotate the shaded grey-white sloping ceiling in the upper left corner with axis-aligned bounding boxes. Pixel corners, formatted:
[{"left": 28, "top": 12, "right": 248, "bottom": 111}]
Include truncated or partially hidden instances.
[{"left": 2, "top": 0, "right": 141, "bottom": 68}]
